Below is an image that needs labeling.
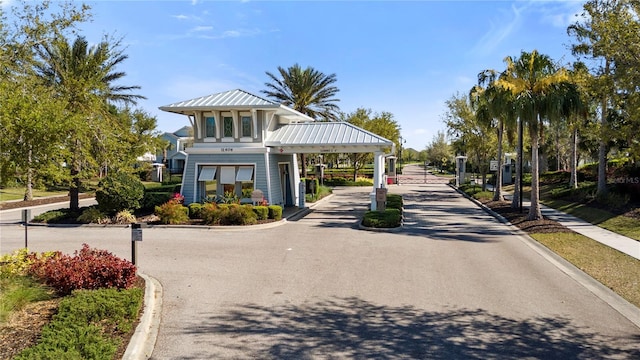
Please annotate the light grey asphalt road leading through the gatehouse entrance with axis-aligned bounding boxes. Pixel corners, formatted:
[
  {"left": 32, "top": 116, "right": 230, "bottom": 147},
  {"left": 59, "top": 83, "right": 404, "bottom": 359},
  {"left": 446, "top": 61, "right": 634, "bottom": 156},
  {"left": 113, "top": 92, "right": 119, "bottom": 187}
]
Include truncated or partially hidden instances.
[{"left": 0, "top": 184, "right": 640, "bottom": 359}]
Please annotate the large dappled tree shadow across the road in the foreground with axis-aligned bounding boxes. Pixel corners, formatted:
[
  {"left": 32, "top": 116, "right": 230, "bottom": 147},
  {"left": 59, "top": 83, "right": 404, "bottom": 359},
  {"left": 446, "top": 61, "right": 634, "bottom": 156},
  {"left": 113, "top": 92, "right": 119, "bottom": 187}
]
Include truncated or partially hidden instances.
[{"left": 185, "top": 297, "right": 640, "bottom": 359}]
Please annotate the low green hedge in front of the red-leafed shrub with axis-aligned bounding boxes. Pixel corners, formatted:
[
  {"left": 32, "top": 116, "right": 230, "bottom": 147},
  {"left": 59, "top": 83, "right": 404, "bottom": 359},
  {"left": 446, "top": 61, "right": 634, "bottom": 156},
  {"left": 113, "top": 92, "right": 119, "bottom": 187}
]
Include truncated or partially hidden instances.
[{"left": 14, "top": 288, "right": 144, "bottom": 360}]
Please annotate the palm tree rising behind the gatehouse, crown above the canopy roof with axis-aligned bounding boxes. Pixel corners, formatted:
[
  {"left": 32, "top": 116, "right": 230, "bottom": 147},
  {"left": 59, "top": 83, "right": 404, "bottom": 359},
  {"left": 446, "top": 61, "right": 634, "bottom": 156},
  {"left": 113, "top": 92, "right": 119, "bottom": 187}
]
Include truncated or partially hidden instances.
[{"left": 262, "top": 64, "right": 340, "bottom": 177}]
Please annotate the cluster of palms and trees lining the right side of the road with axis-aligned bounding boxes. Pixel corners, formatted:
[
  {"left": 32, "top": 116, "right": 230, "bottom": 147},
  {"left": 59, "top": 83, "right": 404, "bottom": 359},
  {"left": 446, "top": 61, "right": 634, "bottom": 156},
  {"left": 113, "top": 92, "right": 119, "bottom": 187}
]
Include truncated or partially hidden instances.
[{"left": 445, "top": 0, "right": 640, "bottom": 220}]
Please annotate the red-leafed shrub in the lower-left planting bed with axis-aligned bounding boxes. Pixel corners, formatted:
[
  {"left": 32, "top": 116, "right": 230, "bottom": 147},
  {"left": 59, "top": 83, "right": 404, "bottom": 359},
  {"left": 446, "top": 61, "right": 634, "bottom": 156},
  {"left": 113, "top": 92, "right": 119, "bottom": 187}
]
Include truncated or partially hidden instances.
[{"left": 29, "top": 244, "right": 136, "bottom": 295}]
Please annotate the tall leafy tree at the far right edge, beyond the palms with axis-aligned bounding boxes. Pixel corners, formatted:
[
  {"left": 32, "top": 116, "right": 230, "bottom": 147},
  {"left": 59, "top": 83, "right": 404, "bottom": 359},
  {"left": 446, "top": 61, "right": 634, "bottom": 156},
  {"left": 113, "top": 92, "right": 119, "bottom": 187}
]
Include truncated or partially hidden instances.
[{"left": 567, "top": 0, "right": 640, "bottom": 196}]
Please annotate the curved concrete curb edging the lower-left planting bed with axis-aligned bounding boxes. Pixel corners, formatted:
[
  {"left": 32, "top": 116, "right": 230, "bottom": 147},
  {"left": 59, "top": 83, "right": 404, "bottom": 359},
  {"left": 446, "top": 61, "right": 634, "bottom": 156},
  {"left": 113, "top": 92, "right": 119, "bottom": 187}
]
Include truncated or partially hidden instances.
[{"left": 122, "top": 273, "right": 162, "bottom": 360}]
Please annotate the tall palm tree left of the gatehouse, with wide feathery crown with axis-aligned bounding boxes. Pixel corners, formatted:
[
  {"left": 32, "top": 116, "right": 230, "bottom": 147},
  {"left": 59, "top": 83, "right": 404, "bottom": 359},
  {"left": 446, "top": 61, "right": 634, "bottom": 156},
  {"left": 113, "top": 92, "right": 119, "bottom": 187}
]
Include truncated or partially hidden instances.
[{"left": 37, "top": 36, "right": 144, "bottom": 210}]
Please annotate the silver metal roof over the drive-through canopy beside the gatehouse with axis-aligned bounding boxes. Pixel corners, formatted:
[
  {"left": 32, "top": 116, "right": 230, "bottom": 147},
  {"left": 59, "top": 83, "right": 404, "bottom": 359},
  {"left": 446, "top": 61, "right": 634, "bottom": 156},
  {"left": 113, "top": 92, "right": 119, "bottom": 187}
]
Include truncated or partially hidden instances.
[{"left": 265, "top": 122, "right": 393, "bottom": 146}]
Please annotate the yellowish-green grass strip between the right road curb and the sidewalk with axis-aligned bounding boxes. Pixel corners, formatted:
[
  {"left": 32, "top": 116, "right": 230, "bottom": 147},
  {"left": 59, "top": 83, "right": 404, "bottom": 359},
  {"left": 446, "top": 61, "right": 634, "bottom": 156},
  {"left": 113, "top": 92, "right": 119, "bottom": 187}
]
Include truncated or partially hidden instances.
[{"left": 529, "top": 233, "right": 640, "bottom": 307}]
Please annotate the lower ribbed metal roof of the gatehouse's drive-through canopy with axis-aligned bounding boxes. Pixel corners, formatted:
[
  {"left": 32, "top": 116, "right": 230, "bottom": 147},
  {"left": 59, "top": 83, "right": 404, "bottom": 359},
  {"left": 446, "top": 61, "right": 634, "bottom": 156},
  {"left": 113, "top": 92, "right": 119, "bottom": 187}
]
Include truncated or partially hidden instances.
[{"left": 265, "top": 121, "right": 394, "bottom": 152}]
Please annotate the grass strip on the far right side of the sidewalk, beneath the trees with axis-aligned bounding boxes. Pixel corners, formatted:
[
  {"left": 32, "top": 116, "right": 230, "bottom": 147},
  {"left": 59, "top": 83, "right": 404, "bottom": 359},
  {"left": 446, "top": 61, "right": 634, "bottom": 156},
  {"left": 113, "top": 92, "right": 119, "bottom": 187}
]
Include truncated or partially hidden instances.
[{"left": 542, "top": 200, "right": 640, "bottom": 241}]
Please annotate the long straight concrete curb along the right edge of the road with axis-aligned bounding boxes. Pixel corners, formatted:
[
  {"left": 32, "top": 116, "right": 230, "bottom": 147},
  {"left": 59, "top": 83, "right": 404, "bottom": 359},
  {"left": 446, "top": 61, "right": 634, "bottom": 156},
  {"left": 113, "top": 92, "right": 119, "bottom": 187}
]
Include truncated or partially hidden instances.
[{"left": 450, "top": 185, "right": 640, "bottom": 328}]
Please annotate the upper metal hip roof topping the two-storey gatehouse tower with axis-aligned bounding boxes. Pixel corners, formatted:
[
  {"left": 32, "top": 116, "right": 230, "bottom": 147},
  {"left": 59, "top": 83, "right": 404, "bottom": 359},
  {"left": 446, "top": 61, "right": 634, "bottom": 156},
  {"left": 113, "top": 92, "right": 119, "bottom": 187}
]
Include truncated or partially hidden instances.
[{"left": 160, "top": 89, "right": 315, "bottom": 122}]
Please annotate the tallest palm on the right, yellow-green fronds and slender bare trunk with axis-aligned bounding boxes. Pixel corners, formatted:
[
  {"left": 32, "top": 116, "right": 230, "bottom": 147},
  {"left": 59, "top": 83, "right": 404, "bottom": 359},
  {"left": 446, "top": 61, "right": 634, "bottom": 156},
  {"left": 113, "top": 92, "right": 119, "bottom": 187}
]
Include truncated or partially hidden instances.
[{"left": 497, "top": 50, "right": 568, "bottom": 220}]
